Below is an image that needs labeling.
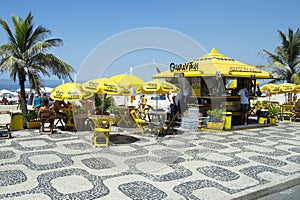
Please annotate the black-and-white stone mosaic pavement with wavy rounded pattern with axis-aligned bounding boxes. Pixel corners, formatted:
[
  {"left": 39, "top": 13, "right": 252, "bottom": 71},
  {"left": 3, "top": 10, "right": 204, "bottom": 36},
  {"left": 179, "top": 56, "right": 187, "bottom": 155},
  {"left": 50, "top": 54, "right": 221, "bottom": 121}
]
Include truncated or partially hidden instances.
[{"left": 0, "top": 122, "right": 300, "bottom": 200}]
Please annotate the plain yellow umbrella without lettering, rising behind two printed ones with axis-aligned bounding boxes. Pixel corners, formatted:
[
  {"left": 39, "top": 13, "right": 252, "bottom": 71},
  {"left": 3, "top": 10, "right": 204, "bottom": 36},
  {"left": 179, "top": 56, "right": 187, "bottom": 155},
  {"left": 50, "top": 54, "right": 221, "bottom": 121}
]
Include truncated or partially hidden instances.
[{"left": 110, "top": 74, "right": 145, "bottom": 88}]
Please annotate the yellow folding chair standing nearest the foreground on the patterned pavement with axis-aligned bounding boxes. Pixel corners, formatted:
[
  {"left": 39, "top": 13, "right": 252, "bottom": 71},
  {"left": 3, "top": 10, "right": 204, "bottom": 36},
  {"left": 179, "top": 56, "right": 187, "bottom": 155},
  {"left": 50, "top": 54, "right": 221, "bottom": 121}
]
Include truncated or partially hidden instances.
[{"left": 89, "top": 117, "right": 114, "bottom": 147}]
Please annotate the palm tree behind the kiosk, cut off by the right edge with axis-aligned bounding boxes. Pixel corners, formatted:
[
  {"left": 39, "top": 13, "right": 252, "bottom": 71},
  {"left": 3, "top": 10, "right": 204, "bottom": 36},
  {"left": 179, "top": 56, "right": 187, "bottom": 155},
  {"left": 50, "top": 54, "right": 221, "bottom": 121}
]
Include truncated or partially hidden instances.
[{"left": 259, "top": 28, "right": 300, "bottom": 84}]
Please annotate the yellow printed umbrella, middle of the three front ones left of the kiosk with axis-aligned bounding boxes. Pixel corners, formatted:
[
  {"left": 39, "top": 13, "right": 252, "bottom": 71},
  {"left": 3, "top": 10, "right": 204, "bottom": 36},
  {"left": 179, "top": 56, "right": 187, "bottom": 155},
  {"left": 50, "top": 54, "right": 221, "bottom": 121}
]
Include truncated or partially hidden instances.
[{"left": 82, "top": 78, "right": 122, "bottom": 95}]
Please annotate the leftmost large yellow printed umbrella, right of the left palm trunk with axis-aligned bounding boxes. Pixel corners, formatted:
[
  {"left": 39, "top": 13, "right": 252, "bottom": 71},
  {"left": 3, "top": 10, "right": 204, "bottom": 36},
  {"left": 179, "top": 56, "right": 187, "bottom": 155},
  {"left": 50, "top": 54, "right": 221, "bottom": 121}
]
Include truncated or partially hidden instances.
[{"left": 50, "top": 82, "right": 92, "bottom": 100}]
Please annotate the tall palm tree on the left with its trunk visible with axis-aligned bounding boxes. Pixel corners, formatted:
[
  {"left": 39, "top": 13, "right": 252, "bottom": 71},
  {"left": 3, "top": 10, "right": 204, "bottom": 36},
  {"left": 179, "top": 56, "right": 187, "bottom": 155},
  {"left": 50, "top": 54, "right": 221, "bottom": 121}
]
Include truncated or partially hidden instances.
[{"left": 0, "top": 13, "right": 74, "bottom": 116}]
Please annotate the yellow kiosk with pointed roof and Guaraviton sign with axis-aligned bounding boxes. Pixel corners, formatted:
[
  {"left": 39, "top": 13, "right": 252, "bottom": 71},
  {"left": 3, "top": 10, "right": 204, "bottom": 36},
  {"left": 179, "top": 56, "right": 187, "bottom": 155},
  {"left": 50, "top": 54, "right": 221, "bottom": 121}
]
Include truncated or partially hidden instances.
[{"left": 152, "top": 48, "right": 273, "bottom": 124}]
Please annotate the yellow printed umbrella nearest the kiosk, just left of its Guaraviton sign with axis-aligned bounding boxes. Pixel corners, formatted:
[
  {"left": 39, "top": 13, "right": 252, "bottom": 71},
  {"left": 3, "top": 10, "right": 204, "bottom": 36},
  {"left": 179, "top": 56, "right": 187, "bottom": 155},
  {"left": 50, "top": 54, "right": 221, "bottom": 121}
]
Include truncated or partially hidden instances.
[{"left": 136, "top": 79, "right": 180, "bottom": 94}]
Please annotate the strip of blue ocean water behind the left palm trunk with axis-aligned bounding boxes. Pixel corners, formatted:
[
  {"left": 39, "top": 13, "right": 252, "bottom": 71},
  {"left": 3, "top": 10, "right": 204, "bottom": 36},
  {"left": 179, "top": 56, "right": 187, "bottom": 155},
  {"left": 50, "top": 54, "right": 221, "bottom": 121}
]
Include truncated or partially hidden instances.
[{"left": 0, "top": 79, "right": 62, "bottom": 91}]
